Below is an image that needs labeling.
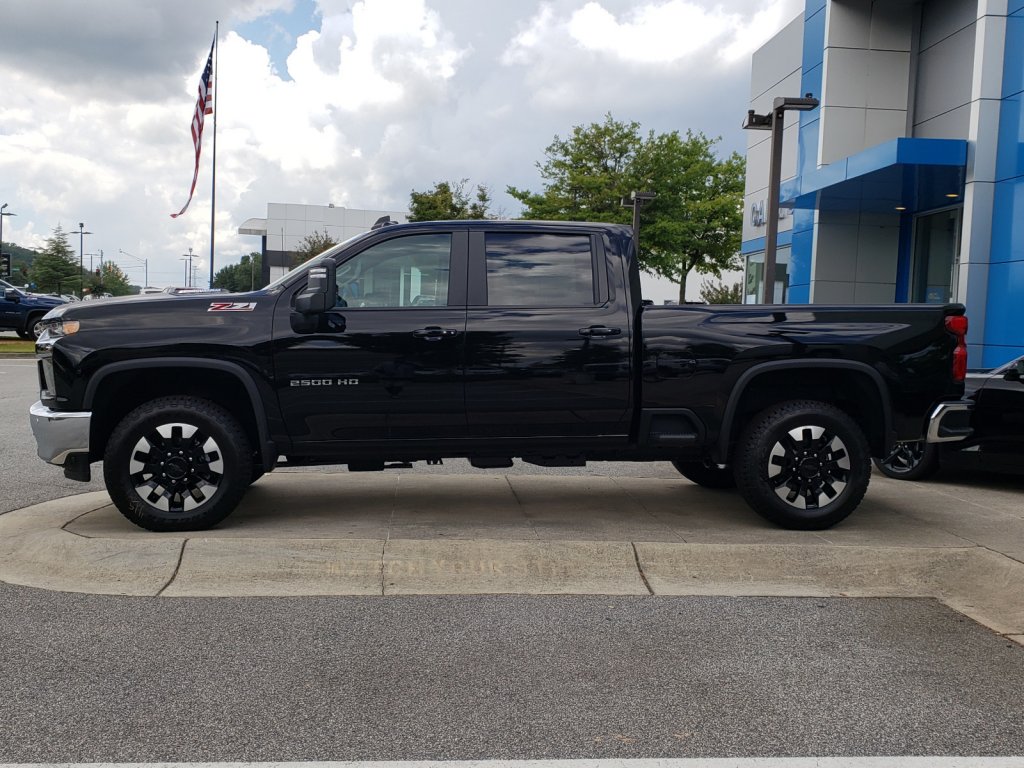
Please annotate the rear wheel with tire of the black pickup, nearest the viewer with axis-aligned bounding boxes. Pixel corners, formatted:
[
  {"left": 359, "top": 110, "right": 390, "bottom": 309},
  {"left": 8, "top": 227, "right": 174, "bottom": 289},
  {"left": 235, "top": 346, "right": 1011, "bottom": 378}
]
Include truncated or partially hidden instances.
[{"left": 734, "top": 400, "right": 871, "bottom": 530}]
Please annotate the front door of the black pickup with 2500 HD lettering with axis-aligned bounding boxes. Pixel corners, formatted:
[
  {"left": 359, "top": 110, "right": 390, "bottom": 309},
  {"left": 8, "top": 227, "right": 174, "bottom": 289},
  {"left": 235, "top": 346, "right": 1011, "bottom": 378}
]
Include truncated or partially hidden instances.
[{"left": 274, "top": 229, "right": 467, "bottom": 450}]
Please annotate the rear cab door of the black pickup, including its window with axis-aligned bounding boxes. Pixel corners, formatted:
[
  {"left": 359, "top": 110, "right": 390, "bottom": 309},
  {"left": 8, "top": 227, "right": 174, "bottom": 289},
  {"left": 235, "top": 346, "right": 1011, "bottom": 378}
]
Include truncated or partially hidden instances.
[{"left": 465, "top": 227, "right": 631, "bottom": 449}]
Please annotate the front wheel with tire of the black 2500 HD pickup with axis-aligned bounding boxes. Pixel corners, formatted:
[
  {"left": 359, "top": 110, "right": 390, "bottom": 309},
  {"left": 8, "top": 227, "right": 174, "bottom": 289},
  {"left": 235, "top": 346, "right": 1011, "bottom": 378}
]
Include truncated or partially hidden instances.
[{"left": 103, "top": 396, "right": 253, "bottom": 531}]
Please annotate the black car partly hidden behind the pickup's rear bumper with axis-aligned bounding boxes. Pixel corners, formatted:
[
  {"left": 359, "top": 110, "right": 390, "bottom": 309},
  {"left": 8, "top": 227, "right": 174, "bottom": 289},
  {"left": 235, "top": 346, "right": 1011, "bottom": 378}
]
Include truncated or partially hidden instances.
[{"left": 874, "top": 355, "right": 1024, "bottom": 480}]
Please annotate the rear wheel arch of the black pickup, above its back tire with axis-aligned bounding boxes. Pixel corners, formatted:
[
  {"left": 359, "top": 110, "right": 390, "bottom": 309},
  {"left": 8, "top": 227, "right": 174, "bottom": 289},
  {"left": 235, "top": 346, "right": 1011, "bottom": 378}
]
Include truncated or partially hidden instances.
[{"left": 716, "top": 359, "right": 893, "bottom": 462}]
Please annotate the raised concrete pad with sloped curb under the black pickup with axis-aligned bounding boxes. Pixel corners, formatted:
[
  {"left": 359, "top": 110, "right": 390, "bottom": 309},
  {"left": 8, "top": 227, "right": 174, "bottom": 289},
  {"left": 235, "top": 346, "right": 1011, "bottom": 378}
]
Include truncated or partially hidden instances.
[{"left": 0, "top": 472, "right": 1024, "bottom": 643}]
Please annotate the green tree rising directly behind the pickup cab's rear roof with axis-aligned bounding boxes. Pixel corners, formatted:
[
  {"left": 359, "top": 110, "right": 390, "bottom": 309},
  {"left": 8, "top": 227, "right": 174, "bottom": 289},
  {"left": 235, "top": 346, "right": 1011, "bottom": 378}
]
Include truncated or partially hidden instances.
[{"left": 507, "top": 114, "right": 644, "bottom": 224}]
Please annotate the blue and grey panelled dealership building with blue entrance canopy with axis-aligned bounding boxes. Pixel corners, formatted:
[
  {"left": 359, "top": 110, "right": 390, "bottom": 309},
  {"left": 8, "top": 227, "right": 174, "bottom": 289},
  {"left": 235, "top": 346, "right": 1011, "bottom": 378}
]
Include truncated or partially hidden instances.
[{"left": 737, "top": 0, "right": 1024, "bottom": 366}]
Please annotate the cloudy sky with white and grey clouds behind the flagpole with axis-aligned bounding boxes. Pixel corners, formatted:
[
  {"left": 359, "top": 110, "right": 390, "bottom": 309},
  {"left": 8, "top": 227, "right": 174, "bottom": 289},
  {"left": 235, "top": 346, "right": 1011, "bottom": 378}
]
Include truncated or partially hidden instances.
[{"left": 0, "top": 0, "right": 803, "bottom": 300}]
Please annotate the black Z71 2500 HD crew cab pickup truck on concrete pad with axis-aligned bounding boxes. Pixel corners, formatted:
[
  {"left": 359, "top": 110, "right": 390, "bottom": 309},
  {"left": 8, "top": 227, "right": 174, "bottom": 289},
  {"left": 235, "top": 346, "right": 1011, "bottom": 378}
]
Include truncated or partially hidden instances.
[{"left": 25, "top": 221, "right": 971, "bottom": 530}]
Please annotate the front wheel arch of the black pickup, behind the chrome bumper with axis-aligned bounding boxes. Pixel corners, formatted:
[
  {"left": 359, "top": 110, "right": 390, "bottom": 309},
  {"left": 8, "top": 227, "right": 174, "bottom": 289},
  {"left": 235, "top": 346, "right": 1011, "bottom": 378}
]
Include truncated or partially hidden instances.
[{"left": 83, "top": 357, "right": 278, "bottom": 468}]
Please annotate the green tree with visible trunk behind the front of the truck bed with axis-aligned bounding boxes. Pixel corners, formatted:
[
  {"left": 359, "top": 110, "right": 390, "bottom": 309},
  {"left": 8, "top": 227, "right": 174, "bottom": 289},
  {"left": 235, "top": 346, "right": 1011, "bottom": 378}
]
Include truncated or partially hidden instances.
[{"left": 636, "top": 131, "right": 745, "bottom": 303}]
